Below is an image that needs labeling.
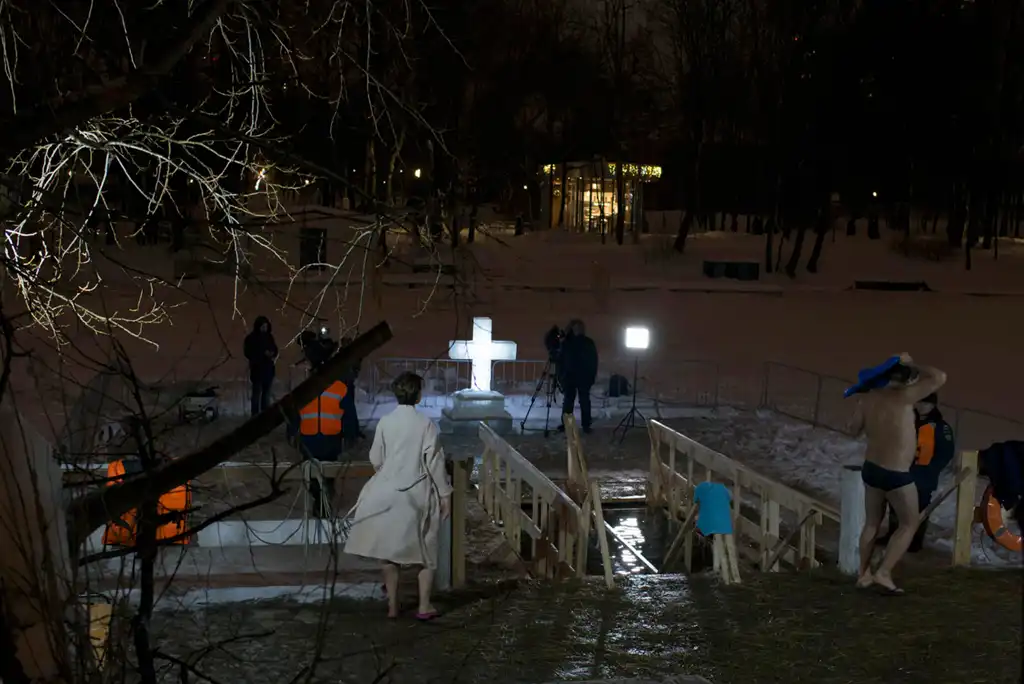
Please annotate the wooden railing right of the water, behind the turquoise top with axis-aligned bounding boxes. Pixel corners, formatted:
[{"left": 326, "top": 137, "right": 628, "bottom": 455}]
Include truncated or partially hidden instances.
[{"left": 647, "top": 421, "right": 840, "bottom": 571}]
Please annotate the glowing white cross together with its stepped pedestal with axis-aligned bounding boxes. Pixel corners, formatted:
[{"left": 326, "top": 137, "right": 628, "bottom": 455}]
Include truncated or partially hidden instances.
[{"left": 440, "top": 317, "right": 516, "bottom": 434}]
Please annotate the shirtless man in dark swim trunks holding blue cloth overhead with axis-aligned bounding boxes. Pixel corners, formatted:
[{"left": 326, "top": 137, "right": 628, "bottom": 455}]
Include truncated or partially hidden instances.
[{"left": 854, "top": 353, "right": 946, "bottom": 594}]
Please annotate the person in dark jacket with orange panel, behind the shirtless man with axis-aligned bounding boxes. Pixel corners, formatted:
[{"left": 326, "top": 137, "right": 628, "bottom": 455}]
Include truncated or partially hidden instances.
[{"left": 879, "top": 392, "right": 956, "bottom": 553}]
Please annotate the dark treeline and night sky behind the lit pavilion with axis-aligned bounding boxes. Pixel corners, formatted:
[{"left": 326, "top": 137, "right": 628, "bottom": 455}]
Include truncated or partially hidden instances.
[{"left": 0, "top": 0, "right": 1024, "bottom": 272}]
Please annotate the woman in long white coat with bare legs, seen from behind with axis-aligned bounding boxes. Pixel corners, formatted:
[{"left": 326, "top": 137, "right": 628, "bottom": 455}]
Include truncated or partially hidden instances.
[{"left": 345, "top": 373, "right": 452, "bottom": 621}]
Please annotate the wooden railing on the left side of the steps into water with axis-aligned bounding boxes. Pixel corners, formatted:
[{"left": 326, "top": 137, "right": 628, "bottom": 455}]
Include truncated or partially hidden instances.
[{"left": 478, "top": 423, "right": 588, "bottom": 580}]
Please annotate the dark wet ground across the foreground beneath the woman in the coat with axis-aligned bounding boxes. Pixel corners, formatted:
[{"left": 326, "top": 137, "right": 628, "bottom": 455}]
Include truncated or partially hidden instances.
[{"left": 146, "top": 570, "right": 1022, "bottom": 684}]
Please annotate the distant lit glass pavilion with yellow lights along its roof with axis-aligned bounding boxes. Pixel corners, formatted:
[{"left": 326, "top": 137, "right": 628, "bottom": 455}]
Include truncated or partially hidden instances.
[{"left": 540, "top": 161, "right": 662, "bottom": 232}]
